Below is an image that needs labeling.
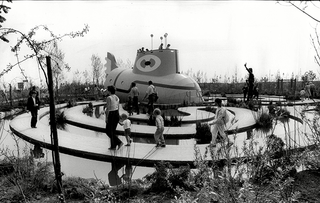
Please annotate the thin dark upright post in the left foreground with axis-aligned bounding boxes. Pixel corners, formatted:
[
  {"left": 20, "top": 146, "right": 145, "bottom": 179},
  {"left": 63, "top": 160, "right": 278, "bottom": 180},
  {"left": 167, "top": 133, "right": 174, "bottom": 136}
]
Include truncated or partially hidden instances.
[{"left": 46, "top": 56, "right": 65, "bottom": 202}]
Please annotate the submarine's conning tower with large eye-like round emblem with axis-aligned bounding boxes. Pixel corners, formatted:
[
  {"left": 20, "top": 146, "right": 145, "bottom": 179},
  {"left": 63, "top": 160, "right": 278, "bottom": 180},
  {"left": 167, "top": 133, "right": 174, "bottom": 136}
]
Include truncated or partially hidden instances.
[{"left": 132, "top": 49, "right": 180, "bottom": 76}]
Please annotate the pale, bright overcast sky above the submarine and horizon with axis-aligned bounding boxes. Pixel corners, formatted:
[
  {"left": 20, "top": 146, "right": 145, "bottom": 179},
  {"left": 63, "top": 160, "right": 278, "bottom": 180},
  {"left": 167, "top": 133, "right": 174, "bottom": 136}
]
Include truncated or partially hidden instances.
[{"left": 0, "top": 0, "right": 320, "bottom": 88}]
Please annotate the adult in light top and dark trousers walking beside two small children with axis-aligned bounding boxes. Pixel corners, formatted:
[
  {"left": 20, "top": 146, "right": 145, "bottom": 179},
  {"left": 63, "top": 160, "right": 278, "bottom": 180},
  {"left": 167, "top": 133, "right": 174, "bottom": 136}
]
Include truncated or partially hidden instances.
[{"left": 104, "top": 85, "right": 123, "bottom": 150}]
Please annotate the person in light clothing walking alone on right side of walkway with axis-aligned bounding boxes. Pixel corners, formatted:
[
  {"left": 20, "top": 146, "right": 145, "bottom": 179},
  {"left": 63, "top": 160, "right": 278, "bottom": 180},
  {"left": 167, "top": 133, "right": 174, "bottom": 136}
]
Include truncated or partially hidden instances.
[{"left": 209, "top": 98, "right": 232, "bottom": 147}]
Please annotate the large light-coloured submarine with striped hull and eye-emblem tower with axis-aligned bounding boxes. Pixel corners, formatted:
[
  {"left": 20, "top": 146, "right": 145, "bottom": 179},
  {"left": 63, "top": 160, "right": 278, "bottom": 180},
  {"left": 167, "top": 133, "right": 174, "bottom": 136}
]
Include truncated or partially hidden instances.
[{"left": 104, "top": 43, "right": 203, "bottom": 104}]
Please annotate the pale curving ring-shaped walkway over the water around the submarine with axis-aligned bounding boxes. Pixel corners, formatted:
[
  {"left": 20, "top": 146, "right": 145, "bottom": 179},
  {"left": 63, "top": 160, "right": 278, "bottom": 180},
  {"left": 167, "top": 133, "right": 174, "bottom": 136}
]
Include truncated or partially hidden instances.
[{"left": 10, "top": 102, "right": 316, "bottom": 167}]
